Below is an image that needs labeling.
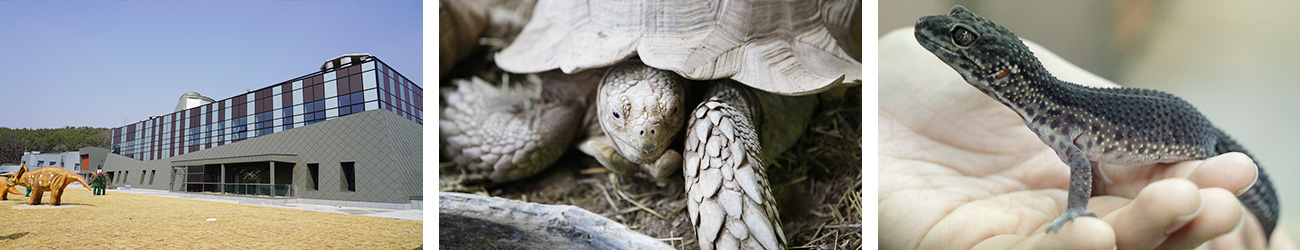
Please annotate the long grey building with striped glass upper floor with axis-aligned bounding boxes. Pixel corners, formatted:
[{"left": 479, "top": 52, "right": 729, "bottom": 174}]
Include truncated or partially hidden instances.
[{"left": 91, "top": 55, "right": 424, "bottom": 204}]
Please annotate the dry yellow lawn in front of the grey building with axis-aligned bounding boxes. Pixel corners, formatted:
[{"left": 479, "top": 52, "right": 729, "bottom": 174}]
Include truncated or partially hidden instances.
[{"left": 0, "top": 186, "right": 424, "bottom": 249}]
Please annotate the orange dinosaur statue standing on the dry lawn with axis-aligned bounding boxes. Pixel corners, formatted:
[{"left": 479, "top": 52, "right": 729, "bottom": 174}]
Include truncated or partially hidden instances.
[{"left": 0, "top": 164, "right": 94, "bottom": 206}]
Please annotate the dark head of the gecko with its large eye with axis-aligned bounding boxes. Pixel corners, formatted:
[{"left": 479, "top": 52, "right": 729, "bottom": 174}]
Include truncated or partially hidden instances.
[{"left": 915, "top": 5, "right": 1047, "bottom": 95}]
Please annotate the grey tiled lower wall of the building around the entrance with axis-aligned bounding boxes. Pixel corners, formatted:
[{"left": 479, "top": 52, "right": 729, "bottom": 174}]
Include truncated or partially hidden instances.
[{"left": 147, "top": 109, "right": 424, "bottom": 203}]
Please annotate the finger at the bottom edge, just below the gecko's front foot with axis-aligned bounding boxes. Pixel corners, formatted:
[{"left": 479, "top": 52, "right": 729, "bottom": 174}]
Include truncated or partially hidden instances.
[{"left": 971, "top": 217, "right": 1115, "bottom": 249}]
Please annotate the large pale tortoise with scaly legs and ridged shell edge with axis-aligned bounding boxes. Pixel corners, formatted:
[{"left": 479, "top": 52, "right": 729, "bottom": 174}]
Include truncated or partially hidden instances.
[{"left": 439, "top": 0, "right": 862, "bottom": 249}]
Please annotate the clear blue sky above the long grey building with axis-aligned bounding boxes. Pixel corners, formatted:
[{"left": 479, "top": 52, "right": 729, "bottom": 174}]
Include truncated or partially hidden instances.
[{"left": 0, "top": 1, "right": 424, "bottom": 128}]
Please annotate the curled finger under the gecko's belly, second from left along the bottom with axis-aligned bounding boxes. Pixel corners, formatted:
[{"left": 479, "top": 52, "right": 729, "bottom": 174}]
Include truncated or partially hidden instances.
[{"left": 1102, "top": 178, "right": 1203, "bottom": 249}]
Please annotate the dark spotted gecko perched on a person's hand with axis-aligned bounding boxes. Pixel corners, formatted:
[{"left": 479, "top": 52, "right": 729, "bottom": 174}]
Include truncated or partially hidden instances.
[{"left": 915, "top": 5, "right": 1279, "bottom": 241}]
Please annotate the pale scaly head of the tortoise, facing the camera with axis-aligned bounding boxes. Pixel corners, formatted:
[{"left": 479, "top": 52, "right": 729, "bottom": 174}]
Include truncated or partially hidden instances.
[{"left": 597, "top": 60, "right": 688, "bottom": 164}]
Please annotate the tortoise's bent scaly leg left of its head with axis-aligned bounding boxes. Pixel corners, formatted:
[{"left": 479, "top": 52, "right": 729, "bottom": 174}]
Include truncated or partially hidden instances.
[{"left": 438, "top": 70, "right": 599, "bottom": 182}]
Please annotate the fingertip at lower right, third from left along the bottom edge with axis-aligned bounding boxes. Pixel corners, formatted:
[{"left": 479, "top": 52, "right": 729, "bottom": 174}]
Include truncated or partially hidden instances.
[{"left": 1160, "top": 188, "right": 1262, "bottom": 249}]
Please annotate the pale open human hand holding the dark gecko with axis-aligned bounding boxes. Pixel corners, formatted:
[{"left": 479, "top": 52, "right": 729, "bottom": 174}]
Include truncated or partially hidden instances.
[{"left": 879, "top": 29, "right": 1290, "bottom": 249}]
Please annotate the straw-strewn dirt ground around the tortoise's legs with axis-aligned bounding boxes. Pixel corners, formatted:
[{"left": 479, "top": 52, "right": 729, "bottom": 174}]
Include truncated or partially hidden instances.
[{"left": 439, "top": 86, "right": 862, "bottom": 249}]
